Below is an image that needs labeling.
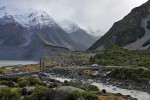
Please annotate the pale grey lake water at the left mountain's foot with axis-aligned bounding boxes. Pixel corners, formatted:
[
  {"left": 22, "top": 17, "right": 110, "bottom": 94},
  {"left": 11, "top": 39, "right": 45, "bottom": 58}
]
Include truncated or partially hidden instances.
[{"left": 0, "top": 60, "right": 38, "bottom": 67}]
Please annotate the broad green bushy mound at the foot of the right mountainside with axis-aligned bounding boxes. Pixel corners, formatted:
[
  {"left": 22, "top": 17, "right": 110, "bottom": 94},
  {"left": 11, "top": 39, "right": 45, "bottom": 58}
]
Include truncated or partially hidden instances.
[{"left": 90, "top": 45, "right": 150, "bottom": 68}]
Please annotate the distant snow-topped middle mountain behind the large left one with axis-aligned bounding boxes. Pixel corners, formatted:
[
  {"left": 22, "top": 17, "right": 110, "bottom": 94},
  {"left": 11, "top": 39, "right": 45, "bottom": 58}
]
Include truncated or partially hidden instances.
[{"left": 59, "top": 20, "right": 97, "bottom": 50}]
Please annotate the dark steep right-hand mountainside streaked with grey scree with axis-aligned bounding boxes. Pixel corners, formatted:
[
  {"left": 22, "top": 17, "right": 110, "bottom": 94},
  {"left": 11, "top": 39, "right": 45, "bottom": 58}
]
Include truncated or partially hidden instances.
[{"left": 89, "top": 0, "right": 150, "bottom": 50}]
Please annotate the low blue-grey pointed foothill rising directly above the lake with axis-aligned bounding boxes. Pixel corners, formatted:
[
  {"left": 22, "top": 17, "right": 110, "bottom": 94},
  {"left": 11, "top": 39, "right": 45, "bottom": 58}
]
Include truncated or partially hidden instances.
[{"left": 0, "top": 34, "right": 70, "bottom": 60}]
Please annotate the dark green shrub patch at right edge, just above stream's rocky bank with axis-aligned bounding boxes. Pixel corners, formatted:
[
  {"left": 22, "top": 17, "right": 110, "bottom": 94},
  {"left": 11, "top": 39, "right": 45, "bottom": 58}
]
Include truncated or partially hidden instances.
[{"left": 110, "top": 68, "right": 150, "bottom": 83}]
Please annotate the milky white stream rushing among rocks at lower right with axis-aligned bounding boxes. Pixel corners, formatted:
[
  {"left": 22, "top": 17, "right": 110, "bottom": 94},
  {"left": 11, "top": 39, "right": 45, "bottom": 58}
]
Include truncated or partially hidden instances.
[{"left": 54, "top": 78, "right": 150, "bottom": 100}]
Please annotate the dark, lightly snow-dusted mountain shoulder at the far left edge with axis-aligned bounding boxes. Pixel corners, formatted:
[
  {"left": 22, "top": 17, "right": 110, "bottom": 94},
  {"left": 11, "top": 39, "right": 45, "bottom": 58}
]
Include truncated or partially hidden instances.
[{"left": 0, "top": 16, "right": 27, "bottom": 46}]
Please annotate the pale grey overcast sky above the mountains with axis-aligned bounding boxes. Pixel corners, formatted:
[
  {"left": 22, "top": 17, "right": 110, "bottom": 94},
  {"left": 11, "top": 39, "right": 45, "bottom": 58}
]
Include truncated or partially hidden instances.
[{"left": 0, "top": 0, "right": 148, "bottom": 32}]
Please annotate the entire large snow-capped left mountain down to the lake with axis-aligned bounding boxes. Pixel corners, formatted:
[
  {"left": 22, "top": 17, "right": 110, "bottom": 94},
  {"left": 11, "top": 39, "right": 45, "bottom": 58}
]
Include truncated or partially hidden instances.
[{"left": 0, "top": 6, "right": 97, "bottom": 60}]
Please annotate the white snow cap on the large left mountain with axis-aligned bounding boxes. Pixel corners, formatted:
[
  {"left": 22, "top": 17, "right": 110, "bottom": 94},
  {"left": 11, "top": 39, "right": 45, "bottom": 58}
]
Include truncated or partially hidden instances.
[{"left": 0, "top": 6, "right": 57, "bottom": 28}]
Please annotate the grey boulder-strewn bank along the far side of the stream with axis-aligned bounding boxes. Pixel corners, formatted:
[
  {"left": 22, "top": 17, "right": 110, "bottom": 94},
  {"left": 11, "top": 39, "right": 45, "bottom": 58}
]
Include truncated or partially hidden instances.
[{"left": 47, "top": 67, "right": 150, "bottom": 93}]
